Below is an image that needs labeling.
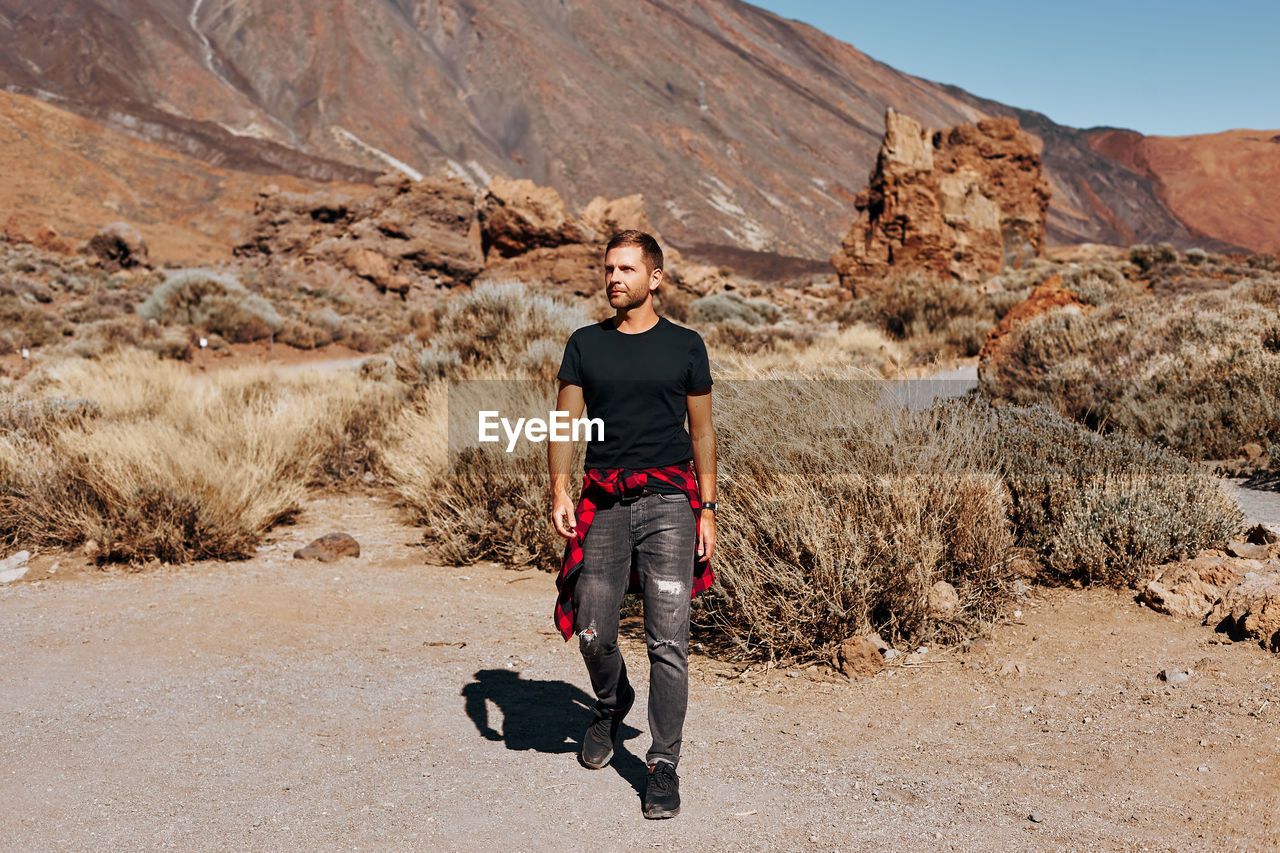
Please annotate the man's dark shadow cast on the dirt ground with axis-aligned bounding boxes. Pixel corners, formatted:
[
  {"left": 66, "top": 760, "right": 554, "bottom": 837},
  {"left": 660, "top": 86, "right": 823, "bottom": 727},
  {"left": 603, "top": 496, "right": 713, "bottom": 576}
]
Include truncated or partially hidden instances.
[{"left": 462, "top": 670, "right": 648, "bottom": 795}]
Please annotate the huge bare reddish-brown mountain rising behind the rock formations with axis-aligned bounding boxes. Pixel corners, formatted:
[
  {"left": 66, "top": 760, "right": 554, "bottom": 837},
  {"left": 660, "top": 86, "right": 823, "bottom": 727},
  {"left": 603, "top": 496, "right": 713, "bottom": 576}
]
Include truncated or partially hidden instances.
[{"left": 0, "top": 0, "right": 1280, "bottom": 260}]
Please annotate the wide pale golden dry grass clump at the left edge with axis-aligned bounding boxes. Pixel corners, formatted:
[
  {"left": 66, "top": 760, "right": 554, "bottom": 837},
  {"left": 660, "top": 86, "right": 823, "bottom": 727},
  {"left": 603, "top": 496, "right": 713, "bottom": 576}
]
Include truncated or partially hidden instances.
[{"left": 0, "top": 352, "right": 390, "bottom": 562}]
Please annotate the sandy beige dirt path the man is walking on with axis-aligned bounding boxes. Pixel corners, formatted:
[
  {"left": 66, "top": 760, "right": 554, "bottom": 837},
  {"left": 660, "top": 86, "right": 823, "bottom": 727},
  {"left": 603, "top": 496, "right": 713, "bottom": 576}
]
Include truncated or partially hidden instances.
[{"left": 0, "top": 496, "right": 1280, "bottom": 850}]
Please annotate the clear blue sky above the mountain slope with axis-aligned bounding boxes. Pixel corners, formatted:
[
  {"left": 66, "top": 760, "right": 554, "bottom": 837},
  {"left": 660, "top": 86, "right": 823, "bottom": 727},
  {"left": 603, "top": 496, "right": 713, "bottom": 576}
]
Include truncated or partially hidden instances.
[{"left": 750, "top": 0, "right": 1280, "bottom": 136}]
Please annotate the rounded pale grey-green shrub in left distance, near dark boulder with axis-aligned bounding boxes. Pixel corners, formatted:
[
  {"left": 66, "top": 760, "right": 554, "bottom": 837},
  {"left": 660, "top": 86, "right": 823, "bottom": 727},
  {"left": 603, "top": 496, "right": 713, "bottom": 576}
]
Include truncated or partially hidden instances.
[{"left": 138, "top": 269, "right": 280, "bottom": 343}]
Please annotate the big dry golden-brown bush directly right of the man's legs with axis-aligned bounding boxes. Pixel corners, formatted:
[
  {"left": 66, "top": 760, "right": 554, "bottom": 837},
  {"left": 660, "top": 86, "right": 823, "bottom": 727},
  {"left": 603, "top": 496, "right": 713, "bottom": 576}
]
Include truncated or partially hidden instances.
[{"left": 695, "top": 380, "right": 1012, "bottom": 660}]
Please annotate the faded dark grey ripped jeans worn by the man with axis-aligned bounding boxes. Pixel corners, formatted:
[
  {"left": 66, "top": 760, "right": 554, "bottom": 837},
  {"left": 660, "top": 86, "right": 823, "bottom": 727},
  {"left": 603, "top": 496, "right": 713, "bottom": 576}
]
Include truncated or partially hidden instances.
[{"left": 575, "top": 492, "right": 696, "bottom": 765}]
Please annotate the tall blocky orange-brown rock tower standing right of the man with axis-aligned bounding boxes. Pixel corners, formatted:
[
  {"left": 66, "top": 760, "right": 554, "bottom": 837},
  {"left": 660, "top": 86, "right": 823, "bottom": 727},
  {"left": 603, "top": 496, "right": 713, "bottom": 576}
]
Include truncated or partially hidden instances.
[{"left": 832, "top": 109, "right": 1050, "bottom": 290}]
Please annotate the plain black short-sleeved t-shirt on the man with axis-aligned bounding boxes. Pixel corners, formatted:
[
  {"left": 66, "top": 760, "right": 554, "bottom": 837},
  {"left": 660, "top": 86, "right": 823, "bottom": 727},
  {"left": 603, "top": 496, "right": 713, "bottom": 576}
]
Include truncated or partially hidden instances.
[{"left": 559, "top": 318, "right": 712, "bottom": 469}]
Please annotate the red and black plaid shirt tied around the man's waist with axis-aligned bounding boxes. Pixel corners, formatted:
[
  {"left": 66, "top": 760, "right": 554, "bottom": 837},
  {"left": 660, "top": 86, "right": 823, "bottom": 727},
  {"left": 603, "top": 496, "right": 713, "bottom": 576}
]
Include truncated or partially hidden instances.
[{"left": 554, "top": 462, "right": 716, "bottom": 640}]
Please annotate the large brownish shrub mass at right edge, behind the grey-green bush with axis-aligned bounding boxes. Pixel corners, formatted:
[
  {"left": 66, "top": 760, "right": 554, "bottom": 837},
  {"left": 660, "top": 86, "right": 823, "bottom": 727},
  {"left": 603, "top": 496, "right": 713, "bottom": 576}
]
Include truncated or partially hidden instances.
[{"left": 982, "top": 278, "right": 1280, "bottom": 459}]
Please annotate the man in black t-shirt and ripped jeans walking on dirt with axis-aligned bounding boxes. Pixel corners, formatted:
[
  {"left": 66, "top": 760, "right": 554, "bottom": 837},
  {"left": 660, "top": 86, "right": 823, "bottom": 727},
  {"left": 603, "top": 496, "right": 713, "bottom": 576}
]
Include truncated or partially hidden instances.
[{"left": 548, "top": 231, "right": 716, "bottom": 818}]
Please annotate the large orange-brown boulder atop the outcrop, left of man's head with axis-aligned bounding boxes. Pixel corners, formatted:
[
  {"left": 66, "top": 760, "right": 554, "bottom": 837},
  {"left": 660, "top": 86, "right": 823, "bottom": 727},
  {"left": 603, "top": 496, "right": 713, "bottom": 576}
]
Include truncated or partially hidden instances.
[{"left": 480, "top": 178, "right": 595, "bottom": 259}]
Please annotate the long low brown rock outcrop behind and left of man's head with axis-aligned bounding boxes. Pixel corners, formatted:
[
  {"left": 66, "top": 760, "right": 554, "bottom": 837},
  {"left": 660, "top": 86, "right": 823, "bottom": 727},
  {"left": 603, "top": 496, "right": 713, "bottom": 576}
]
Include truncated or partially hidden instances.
[{"left": 236, "top": 174, "right": 686, "bottom": 298}]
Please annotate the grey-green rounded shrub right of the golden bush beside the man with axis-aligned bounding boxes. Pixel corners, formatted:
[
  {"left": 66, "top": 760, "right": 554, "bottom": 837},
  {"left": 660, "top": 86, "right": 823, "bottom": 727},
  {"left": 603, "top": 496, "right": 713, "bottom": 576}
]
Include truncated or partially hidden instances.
[{"left": 962, "top": 398, "right": 1243, "bottom": 585}]
